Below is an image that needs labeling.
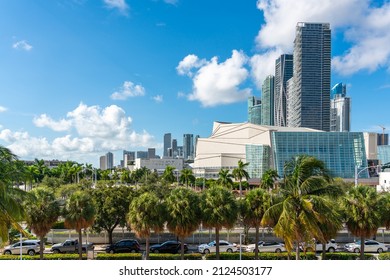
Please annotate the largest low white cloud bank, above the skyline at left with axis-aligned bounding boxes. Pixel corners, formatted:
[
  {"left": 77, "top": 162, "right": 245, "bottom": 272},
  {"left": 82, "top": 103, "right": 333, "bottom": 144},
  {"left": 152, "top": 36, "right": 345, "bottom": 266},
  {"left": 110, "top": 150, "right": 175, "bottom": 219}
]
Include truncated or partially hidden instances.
[{"left": 0, "top": 103, "right": 159, "bottom": 162}]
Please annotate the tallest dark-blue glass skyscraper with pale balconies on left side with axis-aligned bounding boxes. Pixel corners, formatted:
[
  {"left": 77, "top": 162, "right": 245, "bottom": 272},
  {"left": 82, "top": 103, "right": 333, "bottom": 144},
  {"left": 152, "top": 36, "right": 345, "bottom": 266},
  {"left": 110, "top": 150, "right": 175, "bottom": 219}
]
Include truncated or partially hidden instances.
[{"left": 288, "top": 22, "right": 331, "bottom": 131}]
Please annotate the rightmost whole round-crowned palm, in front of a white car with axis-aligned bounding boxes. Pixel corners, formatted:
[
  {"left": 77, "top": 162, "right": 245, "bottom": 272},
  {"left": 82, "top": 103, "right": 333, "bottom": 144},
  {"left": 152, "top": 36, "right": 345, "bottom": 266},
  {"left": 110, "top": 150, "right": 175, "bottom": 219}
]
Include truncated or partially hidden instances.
[{"left": 342, "top": 185, "right": 383, "bottom": 260}]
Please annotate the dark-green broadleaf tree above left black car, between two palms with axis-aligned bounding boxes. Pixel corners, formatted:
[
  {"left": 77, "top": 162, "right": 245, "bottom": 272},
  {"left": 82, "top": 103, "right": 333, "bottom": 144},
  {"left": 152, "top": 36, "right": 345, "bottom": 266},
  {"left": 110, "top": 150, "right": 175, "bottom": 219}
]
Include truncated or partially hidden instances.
[{"left": 92, "top": 185, "right": 132, "bottom": 244}]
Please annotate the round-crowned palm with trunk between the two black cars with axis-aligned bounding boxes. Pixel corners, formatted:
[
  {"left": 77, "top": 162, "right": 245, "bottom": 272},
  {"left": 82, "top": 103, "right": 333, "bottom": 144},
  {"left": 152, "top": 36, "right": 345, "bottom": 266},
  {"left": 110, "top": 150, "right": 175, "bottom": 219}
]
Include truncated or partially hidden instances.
[{"left": 127, "top": 192, "right": 166, "bottom": 259}]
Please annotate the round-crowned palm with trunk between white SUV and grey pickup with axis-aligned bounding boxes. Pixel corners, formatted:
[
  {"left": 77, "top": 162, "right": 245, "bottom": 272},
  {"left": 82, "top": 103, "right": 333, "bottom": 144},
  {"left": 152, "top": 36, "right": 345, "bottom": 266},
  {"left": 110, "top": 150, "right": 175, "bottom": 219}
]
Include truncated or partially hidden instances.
[{"left": 25, "top": 187, "right": 60, "bottom": 260}]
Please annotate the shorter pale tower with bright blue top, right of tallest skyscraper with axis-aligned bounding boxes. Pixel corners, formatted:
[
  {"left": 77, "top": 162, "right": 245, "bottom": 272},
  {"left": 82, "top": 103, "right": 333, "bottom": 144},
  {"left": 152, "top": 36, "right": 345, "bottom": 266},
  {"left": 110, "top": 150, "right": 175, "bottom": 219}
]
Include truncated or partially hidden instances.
[{"left": 330, "top": 83, "right": 351, "bottom": 132}]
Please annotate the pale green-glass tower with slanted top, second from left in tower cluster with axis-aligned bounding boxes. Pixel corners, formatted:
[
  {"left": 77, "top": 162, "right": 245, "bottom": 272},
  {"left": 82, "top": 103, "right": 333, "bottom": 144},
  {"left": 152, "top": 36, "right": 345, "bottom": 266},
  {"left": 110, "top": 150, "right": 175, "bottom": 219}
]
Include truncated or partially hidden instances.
[{"left": 261, "top": 75, "right": 274, "bottom": 125}]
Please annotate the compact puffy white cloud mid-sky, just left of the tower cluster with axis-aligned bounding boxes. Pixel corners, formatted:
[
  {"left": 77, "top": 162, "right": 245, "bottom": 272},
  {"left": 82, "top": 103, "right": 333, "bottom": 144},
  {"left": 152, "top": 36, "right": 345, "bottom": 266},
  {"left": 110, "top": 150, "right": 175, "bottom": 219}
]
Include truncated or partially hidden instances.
[{"left": 177, "top": 50, "right": 251, "bottom": 107}]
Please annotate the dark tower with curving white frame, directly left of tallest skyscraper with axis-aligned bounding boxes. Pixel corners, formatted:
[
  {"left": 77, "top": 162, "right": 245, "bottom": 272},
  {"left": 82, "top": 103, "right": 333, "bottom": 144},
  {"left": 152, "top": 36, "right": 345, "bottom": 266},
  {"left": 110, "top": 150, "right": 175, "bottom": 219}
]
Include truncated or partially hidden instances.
[{"left": 274, "top": 54, "right": 293, "bottom": 126}]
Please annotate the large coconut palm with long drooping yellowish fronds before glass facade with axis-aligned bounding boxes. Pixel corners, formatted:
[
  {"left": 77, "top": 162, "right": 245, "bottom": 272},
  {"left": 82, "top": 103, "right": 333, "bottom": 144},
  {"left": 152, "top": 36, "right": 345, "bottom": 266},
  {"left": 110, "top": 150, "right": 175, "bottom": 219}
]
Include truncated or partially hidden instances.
[{"left": 263, "top": 155, "right": 339, "bottom": 259}]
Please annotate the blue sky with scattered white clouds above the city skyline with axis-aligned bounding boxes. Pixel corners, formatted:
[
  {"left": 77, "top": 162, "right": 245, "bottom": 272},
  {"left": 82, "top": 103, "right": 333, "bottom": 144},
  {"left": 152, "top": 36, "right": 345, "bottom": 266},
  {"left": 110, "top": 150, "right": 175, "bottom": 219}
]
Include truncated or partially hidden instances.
[{"left": 0, "top": 0, "right": 390, "bottom": 165}]
